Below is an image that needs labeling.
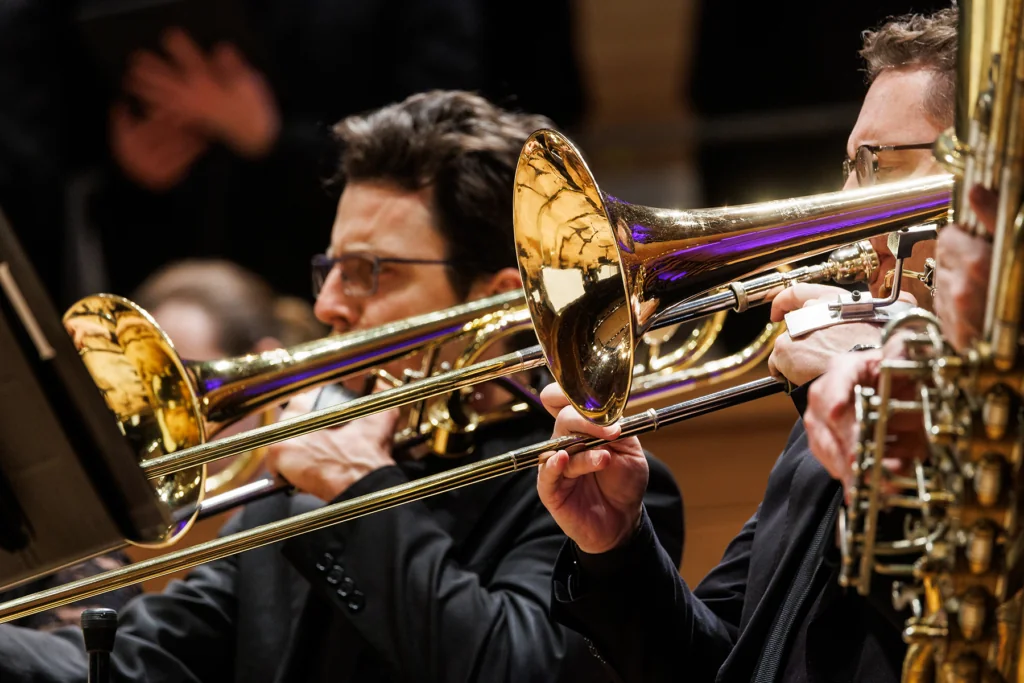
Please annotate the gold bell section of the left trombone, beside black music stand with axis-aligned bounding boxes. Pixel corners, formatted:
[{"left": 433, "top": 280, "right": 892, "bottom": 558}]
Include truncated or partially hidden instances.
[{"left": 63, "top": 291, "right": 528, "bottom": 548}]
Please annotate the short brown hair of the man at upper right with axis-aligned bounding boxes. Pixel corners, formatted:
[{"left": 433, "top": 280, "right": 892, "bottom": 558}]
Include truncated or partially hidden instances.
[{"left": 860, "top": 3, "right": 959, "bottom": 124}]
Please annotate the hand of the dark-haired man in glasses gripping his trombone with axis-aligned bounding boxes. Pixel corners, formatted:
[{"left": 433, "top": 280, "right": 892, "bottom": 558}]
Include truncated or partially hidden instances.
[{"left": 266, "top": 391, "right": 398, "bottom": 502}]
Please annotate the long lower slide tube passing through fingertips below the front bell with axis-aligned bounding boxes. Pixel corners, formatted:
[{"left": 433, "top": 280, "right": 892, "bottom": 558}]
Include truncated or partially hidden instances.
[{"left": 0, "top": 378, "right": 784, "bottom": 623}]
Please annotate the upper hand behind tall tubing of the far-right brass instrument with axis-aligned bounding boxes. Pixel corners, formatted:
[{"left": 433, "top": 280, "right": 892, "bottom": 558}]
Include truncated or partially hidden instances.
[{"left": 935, "top": 185, "right": 998, "bottom": 351}]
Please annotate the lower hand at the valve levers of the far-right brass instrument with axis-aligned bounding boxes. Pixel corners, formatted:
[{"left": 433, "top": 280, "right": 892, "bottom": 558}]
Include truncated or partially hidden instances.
[{"left": 803, "top": 336, "right": 927, "bottom": 501}]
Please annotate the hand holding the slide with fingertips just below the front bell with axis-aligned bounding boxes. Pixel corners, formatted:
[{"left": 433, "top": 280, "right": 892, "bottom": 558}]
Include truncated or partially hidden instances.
[{"left": 537, "top": 384, "right": 648, "bottom": 554}]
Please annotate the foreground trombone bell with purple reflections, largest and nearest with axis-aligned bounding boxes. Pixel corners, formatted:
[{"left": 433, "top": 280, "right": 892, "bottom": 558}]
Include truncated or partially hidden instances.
[{"left": 513, "top": 130, "right": 952, "bottom": 425}]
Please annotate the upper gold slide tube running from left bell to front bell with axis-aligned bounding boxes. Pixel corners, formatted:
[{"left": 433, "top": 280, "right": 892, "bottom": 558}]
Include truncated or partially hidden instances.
[{"left": 139, "top": 346, "right": 545, "bottom": 478}]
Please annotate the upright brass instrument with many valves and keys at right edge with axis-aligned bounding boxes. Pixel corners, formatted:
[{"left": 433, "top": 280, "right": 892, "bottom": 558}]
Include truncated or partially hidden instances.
[{"left": 840, "top": 0, "right": 1024, "bottom": 683}]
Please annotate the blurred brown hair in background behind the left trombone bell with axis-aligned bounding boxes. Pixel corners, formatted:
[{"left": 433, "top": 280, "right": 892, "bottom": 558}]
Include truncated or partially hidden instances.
[{"left": 132, "top": 259, "right": 326, "bottom": 355}]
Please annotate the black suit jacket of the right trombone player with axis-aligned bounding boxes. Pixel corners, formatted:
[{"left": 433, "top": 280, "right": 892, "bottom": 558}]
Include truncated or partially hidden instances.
[{"left": 552, "top": 422, "right": 906, "bottom": 683}]
